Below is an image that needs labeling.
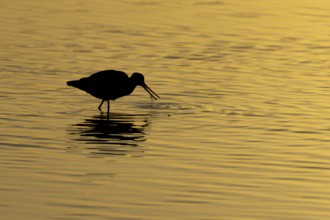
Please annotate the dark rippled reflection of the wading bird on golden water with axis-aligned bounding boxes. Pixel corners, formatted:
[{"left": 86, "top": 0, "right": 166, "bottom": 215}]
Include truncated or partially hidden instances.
[{"left": 69, "top": 113, "right": 149, "bottom": 156}]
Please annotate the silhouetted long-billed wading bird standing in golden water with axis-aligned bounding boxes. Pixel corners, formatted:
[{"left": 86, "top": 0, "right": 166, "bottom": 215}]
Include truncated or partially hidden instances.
[{"left": 67, "top": 70, "right": 160, "bottom": 115}]
